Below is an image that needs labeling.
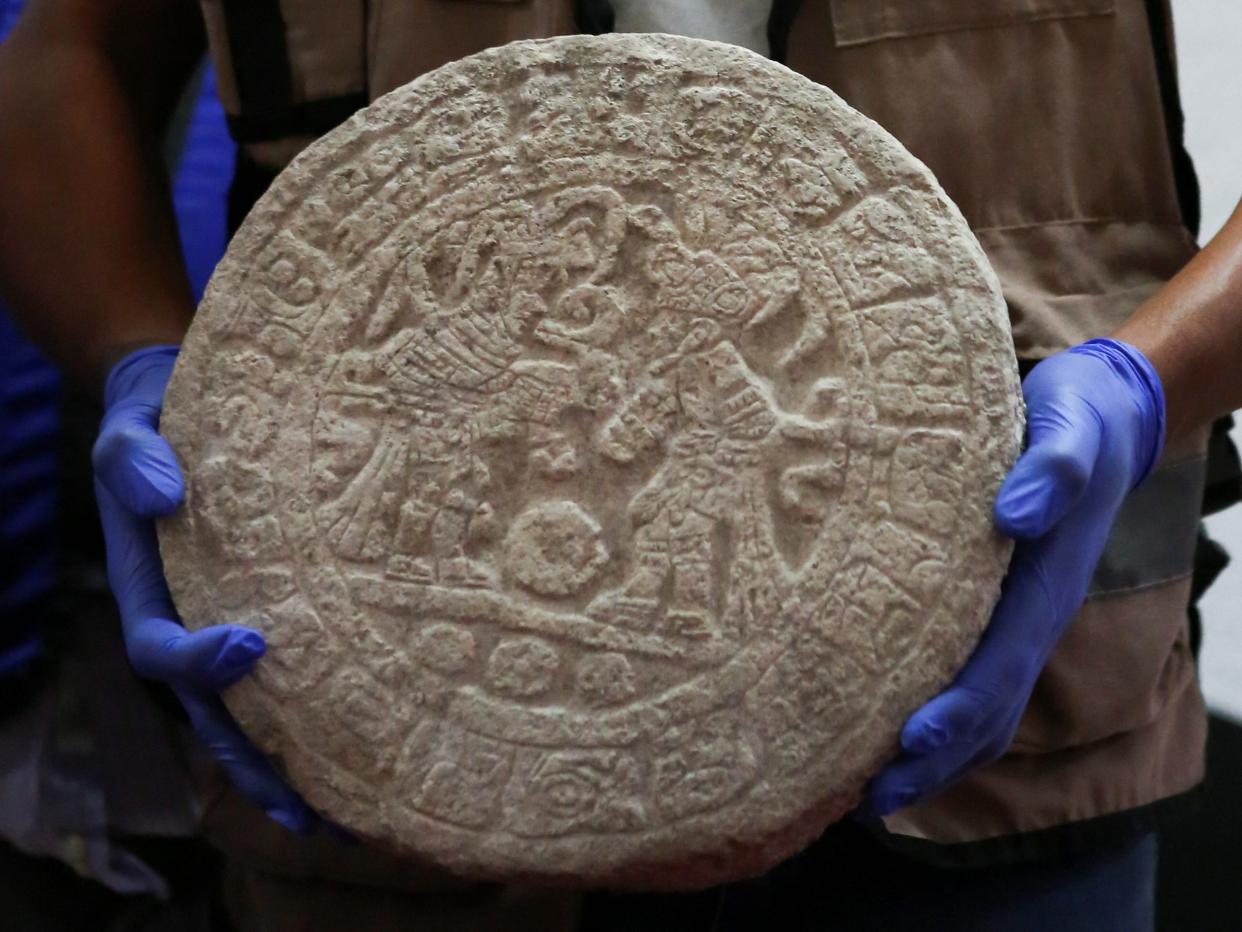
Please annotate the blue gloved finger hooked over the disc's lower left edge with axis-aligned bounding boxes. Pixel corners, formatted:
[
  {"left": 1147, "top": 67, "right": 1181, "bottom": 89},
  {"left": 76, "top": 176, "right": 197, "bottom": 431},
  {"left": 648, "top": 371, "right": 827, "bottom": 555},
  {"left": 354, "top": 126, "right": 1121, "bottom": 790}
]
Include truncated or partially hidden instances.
[{"left": 125, "top": 618, "right": 265, "bottom": 692}]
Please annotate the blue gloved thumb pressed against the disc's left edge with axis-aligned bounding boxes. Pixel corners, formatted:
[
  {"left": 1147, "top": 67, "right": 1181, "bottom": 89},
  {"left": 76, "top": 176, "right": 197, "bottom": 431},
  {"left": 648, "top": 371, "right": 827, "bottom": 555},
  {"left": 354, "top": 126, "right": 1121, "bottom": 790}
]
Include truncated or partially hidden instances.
[{"left": 92, "top": 415, "right": 185, "bottom": 518}]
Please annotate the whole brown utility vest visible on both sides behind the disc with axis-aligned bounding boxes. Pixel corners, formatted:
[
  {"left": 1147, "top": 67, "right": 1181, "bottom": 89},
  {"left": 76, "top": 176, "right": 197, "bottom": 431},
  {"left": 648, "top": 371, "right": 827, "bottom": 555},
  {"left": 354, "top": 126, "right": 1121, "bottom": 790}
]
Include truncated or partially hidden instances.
[{"left": 202, "top": 0, "right": 1206, "bottom": 874}]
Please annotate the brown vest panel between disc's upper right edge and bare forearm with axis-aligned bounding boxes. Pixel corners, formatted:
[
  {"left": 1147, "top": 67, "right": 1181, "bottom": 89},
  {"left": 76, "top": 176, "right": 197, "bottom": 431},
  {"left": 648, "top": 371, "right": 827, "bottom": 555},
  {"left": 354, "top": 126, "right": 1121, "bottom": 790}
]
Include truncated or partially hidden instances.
[{"left": 789, "top": 0, "right": 1195, "bottom": 358}]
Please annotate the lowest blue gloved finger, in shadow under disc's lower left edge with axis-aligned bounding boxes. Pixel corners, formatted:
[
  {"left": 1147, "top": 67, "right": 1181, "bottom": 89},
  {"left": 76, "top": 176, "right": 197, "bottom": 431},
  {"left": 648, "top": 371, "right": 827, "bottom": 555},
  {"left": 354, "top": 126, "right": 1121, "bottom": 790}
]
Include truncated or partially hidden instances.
[{"left": 178, "top": 690, "right": 318, "bottom": 834}]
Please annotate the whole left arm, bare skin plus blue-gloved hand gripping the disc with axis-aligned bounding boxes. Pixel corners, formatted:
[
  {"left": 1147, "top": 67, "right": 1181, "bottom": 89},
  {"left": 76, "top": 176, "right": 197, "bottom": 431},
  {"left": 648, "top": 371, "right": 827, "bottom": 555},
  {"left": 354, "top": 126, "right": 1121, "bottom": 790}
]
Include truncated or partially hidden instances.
[{"left": 0, "top": 0, "right": 318, "bottom": 831}]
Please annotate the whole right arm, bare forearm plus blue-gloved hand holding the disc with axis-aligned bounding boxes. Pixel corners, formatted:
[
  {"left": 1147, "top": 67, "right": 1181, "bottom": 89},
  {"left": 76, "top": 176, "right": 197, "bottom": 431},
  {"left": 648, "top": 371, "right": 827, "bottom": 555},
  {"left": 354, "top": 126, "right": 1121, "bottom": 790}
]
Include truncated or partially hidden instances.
[{"left": 864, "top": 198, "right": 1242, "bottom": 815}]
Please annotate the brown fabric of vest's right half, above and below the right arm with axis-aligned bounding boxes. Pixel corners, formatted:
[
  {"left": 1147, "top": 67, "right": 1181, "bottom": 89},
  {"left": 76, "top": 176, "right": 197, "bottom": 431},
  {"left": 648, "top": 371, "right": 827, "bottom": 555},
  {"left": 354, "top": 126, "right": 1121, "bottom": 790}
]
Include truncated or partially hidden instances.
[{"left": 789, "top": 0, "right": 1203, "bottom": 843}]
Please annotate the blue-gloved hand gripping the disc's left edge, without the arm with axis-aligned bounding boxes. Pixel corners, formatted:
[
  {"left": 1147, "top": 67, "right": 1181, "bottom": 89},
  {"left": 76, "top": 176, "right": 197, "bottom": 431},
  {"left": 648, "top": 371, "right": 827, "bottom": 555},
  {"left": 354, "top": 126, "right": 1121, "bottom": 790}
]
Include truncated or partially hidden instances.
[{"left": 92, "top": 345, "right": 317, "bottom": 831}]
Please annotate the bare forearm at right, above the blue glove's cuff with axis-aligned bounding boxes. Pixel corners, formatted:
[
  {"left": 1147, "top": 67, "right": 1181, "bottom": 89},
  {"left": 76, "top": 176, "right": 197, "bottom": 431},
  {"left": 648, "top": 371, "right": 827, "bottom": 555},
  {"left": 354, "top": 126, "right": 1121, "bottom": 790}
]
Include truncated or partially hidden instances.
[{"left": 1114, "top": 197, "right": 1242, "bottom": 439}]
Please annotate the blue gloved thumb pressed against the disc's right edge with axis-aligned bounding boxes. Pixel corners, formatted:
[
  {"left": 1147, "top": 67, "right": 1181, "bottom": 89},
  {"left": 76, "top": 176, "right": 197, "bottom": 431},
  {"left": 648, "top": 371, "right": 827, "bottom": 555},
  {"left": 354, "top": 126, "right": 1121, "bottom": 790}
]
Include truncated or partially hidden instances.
[{"left": 995, "top": 399, "right": 1102, "bottom": 539}]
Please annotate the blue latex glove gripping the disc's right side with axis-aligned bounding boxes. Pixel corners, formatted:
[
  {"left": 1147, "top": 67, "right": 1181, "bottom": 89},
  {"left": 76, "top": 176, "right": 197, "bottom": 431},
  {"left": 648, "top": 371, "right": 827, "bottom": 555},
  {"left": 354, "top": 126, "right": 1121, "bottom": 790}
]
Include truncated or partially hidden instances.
[{"left": 863, "top": 339, "right": 1165, "bottom": 815}]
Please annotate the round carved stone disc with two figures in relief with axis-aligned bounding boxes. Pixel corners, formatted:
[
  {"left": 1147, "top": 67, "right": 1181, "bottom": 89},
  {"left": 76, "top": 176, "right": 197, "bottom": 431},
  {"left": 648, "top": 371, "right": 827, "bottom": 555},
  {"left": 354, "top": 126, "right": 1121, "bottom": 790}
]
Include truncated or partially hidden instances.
[{"left": 160, "top": 36, "right": 1021, "bottom": 887}]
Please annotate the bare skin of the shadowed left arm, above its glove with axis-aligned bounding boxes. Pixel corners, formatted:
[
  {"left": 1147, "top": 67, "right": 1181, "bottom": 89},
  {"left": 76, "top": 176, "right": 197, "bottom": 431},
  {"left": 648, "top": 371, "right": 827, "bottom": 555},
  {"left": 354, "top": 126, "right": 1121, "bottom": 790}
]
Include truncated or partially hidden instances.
[{"left": 0, "top": 0, "right": 204, "bottom": 390}]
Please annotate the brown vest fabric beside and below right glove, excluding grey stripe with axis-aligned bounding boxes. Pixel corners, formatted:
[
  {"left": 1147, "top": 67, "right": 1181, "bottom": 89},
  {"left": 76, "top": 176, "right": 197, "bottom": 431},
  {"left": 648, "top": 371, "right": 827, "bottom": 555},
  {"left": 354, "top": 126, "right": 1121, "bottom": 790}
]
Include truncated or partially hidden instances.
[{"left": 884, "top": 432, "right": 1207, "bottom": 844}]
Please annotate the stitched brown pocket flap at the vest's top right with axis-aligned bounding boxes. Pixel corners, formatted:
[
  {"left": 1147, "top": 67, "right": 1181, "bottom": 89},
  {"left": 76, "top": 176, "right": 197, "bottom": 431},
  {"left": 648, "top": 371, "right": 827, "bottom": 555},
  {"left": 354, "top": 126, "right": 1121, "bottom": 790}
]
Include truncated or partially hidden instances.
[{"left": 831, "top": 0, "right": 1117, "bottom": 46}]
